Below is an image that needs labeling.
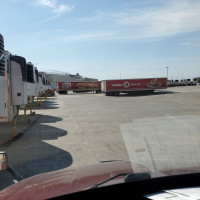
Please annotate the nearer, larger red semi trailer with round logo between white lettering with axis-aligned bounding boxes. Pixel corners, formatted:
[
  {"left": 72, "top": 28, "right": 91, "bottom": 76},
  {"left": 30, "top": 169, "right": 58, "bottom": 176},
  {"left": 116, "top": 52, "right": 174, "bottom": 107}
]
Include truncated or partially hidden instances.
[{"left": 101, "top": 78, "right": 167, "bottom": 96}]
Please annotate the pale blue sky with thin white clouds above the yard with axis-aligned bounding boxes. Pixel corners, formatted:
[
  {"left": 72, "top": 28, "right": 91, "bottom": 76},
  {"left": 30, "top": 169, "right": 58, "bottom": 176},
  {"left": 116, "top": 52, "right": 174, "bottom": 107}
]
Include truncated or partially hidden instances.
[{"left": 0, "top": 0, "right": 200, "bottom": 80}]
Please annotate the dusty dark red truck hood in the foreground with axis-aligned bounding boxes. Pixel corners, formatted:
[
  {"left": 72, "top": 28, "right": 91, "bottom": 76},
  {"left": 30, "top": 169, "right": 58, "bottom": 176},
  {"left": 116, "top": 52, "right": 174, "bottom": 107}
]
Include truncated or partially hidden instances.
[{"left": 0, "top": 161, "right": 149, "bottom": 200}]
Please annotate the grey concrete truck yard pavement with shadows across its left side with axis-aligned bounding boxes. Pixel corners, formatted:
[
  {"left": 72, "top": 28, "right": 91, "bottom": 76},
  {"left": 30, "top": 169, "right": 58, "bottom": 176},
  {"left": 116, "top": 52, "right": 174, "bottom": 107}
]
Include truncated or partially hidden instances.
[{"left": 0, "top": 86, "right": 200, "bottom": 189}]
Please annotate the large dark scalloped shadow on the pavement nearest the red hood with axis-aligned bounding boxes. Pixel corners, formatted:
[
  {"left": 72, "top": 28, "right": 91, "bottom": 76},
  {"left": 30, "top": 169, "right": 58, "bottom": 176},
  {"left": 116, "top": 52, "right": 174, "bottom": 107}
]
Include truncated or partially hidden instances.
[{"left": 0, "top": 115, "right": 73, "bottom": 178}]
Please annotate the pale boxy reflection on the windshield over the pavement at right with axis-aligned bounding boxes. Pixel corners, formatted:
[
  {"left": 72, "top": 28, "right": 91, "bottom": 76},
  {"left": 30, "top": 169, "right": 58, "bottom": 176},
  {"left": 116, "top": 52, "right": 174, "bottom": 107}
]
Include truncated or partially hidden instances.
[{"left": 120, "top": 115, "right": 200, "bottom": 171}]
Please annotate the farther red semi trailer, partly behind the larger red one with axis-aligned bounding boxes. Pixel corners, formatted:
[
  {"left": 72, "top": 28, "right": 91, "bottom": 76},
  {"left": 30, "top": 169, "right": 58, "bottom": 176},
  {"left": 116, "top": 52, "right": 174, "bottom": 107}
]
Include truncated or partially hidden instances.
[{"left": 57, "top": 81, "right": 101, "bottom": 94}]
